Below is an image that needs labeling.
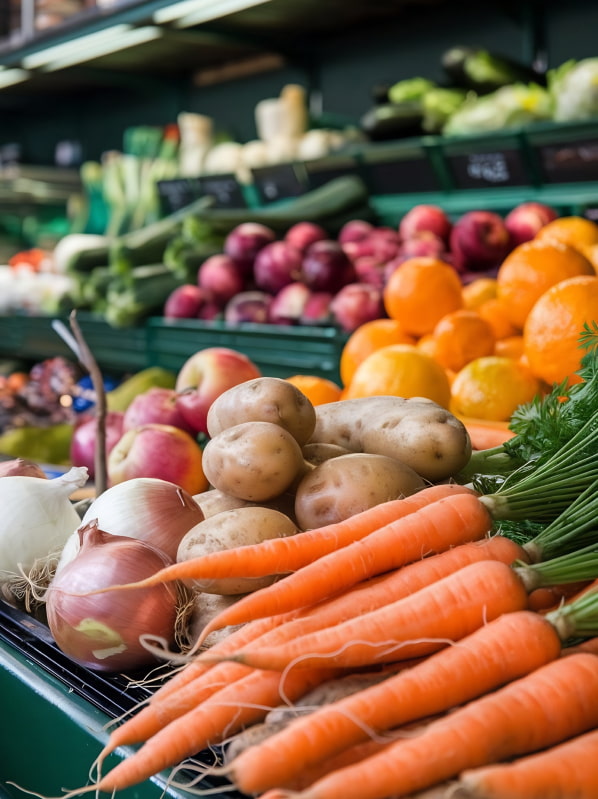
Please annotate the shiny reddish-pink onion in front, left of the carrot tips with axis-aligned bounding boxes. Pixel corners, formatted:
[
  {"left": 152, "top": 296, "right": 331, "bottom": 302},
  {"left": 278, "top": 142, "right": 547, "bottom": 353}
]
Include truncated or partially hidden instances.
[{"left": 46, "top": 522, "right": 178, "bottom": 672}]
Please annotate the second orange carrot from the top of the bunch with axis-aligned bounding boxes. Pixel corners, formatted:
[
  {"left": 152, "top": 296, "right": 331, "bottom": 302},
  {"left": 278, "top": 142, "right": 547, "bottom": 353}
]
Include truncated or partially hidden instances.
[{"left": 195, "top": 492, "right": 492, "bottom": 640}]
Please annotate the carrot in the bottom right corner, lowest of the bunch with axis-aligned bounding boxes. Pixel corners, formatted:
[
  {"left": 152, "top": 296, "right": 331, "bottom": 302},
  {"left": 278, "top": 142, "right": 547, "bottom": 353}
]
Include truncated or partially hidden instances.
[{"left": 458, "top": 730, "right": 598, "bottom": 799}]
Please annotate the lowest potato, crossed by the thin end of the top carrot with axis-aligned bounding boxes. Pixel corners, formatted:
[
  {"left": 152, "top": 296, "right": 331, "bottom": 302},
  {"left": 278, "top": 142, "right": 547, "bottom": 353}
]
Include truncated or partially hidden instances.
[{"left": 177, "top": 507, "right": 297, "bottom": 595}]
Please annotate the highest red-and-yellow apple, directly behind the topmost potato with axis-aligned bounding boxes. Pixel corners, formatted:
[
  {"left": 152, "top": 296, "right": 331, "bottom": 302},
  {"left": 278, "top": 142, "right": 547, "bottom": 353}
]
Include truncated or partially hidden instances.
[{"left": 175, "top": 347, "right": 262, "bottom": 435}]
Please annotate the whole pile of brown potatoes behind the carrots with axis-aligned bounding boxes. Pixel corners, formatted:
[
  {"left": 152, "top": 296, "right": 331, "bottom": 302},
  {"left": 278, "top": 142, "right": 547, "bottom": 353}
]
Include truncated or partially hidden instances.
[{"left": 178, "top": 377, "right": 471, "bottom": 612}]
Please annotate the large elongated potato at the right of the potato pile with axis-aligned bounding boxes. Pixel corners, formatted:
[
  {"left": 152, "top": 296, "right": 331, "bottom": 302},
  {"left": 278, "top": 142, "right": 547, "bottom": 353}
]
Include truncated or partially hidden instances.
[{"left": 309, "top": 396, "right": 471, "bottom": 482}]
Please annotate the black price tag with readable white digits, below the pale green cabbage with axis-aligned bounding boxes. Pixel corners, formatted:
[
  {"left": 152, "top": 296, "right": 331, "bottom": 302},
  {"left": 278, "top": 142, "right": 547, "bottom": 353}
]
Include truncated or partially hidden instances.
[{"left": 447, "top": 149, "right": 529, "bottom": 189}]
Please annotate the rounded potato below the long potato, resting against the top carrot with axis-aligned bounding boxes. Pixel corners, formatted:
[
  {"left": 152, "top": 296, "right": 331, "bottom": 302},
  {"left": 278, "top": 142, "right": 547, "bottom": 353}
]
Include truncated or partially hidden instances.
[{"left": 295, "top": 452, "right": 426, "bottom": 530}]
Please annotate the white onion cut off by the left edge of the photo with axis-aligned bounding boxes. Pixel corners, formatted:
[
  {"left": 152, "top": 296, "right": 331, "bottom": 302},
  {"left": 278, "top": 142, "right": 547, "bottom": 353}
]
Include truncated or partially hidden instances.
[{"left": 0, "top": 466, "right": 88, "bottom": 596}]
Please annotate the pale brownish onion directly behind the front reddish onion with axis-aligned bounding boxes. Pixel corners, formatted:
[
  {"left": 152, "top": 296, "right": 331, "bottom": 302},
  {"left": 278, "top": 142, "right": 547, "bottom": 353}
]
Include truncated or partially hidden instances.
[{"left": 56, "top": 477, "right": 204, "bottom": 574}]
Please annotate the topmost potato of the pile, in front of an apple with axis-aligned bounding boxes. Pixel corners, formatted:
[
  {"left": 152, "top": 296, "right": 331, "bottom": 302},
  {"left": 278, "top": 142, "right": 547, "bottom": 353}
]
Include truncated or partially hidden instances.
[{"left": 207, "top": 377, "right": 316, "bottom": 445}]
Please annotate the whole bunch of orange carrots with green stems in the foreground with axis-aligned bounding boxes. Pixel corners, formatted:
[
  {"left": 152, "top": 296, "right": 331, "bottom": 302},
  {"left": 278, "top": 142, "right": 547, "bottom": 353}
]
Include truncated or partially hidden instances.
[{"left": 62, "top": 332, "right": 598, "bottom": 799}]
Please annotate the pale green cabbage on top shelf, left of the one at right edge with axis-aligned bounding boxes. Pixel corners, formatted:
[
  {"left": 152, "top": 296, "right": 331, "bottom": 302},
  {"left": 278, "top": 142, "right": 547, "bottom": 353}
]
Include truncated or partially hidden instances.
[{"left": 442, "top": 83, "right": 552, "bottom": 136}]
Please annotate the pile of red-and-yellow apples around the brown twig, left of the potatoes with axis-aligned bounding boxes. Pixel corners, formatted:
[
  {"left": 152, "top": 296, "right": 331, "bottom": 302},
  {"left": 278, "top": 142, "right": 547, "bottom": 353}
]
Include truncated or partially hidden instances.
[{"left": 70, "top": 347, "right": 261, "bottom": 494}]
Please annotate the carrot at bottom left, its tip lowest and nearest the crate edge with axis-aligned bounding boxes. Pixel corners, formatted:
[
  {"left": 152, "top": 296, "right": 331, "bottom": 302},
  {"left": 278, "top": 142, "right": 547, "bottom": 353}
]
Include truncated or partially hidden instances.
[{"left": 93, "top": 669, "right": 338, "bottom": 793}]
